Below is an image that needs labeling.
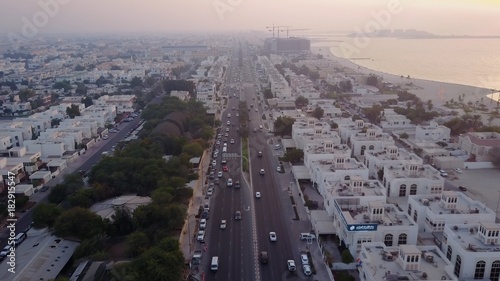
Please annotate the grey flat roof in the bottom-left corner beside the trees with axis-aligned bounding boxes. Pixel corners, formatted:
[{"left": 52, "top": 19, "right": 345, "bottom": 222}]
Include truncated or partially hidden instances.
[{"left": 0, "top": 229, "right": 80, "bottom": 281}]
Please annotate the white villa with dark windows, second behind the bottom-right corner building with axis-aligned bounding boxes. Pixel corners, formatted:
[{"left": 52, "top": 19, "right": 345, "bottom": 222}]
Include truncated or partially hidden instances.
[{"left": 383, "top": 161, "right": 444, "bottom": 197}]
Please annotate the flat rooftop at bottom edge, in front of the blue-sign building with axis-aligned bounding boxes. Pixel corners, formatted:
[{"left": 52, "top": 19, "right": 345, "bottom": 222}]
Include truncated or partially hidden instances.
[{"left": 360, "top": 242, "right": 458, "bottom": 281}]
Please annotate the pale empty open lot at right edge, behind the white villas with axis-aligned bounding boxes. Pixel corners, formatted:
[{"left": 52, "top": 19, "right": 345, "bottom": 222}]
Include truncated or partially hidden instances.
[{"left": 451, "top": 166, "right": 500, "bottom": 220}]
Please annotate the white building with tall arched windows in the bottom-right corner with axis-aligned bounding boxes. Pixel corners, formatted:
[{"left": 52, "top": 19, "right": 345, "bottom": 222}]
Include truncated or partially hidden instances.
[{"left": 442, "top": 220, "right": 500, "bottom": 281}]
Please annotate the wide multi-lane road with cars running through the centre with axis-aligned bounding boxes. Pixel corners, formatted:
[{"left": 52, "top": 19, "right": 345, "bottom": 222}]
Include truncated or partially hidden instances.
[{"left": 202, "top": 43, "right": 306, "bottom": 281}]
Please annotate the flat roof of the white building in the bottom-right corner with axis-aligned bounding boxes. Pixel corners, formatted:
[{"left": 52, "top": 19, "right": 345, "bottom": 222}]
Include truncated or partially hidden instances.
[{"left": 448, "top": 222, "right": 500, "bottom": 253}]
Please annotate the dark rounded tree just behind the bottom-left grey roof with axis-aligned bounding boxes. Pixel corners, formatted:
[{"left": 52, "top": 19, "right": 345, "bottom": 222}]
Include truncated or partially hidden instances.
[{"left": 54, "top": 207, "right": 105, "bottom": 240}]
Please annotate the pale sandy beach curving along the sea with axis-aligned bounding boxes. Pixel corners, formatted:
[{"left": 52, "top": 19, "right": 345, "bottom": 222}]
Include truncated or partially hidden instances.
[{"left": 311, "top": 47, "right": 498, "bottom": 109}]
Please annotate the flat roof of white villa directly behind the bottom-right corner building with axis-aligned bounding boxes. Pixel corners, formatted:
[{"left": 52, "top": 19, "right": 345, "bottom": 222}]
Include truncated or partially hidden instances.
[{"left": 412, "top": 191, "right": 492, "bottom": 216}]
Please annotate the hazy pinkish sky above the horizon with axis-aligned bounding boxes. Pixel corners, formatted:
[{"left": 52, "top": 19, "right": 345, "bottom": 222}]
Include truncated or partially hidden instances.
[{"left": 0, "top": 0, "right": 500, "bottom": 35}]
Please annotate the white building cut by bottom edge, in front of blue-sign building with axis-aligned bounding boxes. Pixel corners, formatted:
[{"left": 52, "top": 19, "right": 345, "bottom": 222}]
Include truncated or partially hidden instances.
[{"left": 358, "top": 242, "right": 462, "bottom": 281}]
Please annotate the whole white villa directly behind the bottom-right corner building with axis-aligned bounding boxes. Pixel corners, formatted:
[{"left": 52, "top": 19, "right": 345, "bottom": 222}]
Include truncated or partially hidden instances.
[{"left": 407, "top": 191, "right": 495, "bottom": 233}]
